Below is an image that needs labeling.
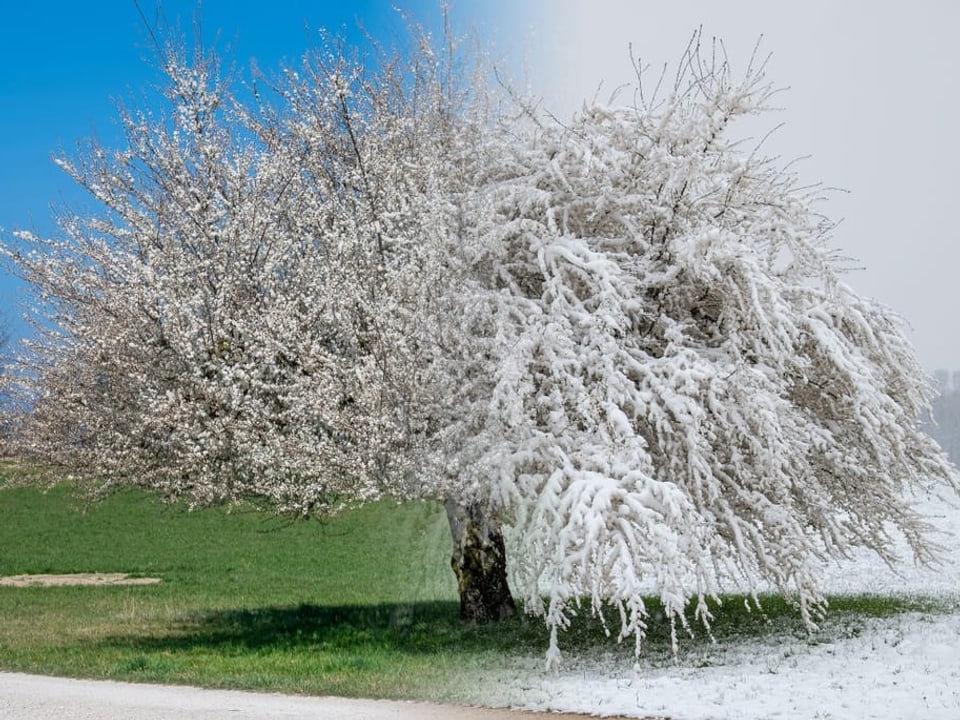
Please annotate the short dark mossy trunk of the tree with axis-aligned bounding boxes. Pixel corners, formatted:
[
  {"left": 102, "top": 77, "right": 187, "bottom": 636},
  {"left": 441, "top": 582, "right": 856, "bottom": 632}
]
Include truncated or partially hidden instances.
[{"left": 444, "top": 500, "right": 517, "bottom": 623}]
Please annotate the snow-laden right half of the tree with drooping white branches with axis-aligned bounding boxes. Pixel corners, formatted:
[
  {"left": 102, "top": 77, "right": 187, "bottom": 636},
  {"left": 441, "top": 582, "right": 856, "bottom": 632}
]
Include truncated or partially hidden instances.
[{"left": 446, "top": 42, "right": 956, "bottom": 652}]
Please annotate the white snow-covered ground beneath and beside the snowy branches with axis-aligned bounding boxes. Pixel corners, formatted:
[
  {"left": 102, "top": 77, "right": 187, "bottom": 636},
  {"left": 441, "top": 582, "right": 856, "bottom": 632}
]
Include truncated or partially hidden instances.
[{"left": 497, "top": 490, "right": 960, "bottom": 720}]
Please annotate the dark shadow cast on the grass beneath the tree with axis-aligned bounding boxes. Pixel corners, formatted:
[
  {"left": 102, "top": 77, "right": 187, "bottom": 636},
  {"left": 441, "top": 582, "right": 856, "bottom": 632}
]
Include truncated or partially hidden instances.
[{"left": 86, "top": 596, "right": 931, "bottom": 655}]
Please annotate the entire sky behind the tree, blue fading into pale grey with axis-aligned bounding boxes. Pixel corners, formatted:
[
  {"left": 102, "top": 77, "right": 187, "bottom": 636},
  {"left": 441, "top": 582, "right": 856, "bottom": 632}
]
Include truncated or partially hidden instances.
[{"left": 0, "top": 0, "right": 960, "bottom": 370}]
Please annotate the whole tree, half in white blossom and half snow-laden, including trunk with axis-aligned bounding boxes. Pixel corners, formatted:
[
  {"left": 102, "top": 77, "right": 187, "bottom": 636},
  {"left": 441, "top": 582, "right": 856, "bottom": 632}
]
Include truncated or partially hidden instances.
[{"left": 8, "top": 29, "right": 958, "bottom": 658}]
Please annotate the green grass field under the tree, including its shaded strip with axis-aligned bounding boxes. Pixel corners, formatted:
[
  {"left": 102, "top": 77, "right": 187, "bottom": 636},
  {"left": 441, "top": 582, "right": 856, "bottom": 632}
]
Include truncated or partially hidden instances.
[{"left": 0, "top": 466, "right": 944, "bottom": 700}]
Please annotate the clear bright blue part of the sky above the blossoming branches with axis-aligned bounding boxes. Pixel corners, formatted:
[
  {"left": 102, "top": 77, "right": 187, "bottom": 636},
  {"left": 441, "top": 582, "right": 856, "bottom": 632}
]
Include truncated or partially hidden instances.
[{"left": 0, "top": 0, "right": 469, "bottom": 344}]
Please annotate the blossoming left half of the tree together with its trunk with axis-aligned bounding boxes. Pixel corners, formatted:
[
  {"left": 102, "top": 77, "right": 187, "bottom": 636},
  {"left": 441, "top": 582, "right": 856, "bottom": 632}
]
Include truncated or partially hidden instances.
[{"left": 8, "top": 28, "right": 514, "bottom": 621}]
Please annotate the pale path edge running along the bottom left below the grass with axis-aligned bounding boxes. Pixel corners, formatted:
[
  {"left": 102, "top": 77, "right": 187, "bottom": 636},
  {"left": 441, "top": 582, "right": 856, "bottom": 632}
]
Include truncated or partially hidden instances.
[{"left": 0, "top": 673, "right": 644, "bottom": 720}]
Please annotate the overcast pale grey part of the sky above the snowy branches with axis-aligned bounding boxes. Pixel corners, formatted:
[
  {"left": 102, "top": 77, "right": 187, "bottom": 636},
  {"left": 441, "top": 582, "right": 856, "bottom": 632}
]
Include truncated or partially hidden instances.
[{"left": 475, "top": 0, "right": 960, "bottom": 369}]
